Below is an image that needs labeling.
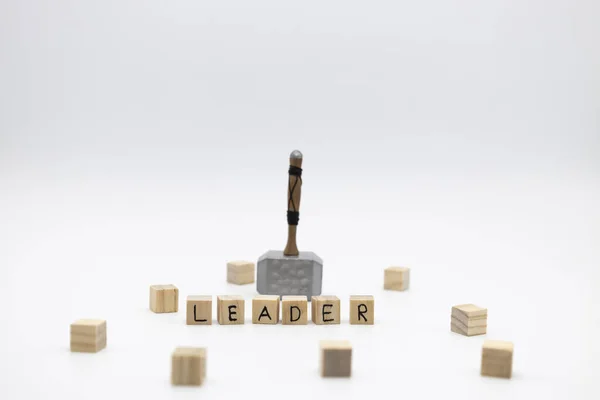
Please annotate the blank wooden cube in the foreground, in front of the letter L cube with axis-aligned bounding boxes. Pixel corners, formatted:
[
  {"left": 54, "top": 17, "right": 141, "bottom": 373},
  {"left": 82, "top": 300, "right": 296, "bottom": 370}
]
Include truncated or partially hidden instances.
[{"left": 171, "top": 347, "right": 206, "bottom": 386}]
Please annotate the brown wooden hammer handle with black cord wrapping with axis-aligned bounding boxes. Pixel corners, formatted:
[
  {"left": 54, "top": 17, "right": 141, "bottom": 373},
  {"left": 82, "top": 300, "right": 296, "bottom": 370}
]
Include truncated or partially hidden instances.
[{"left": 283, "top": 150, "right": 302, "bottom": 256}]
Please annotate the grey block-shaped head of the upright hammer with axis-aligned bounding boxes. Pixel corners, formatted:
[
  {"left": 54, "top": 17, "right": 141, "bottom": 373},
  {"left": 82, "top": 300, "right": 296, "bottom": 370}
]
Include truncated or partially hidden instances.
[{"left": 256, "top": 250, "right": 323, "bottom": 301}]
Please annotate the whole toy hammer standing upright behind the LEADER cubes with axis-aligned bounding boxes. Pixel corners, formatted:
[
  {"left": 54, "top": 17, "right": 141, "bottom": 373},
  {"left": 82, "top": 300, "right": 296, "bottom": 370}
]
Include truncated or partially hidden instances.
[{"left": 256, "top": 150, "right": 323, "bottom": 300}]
